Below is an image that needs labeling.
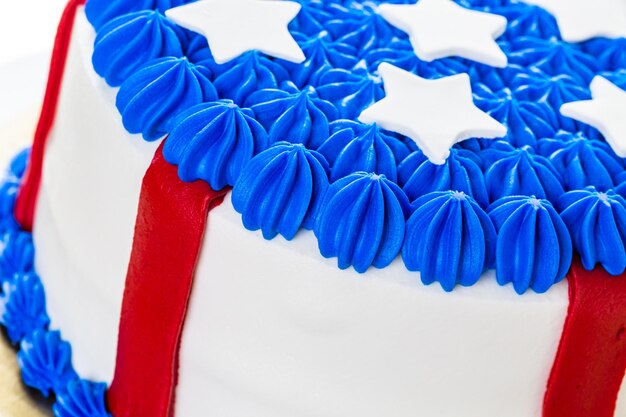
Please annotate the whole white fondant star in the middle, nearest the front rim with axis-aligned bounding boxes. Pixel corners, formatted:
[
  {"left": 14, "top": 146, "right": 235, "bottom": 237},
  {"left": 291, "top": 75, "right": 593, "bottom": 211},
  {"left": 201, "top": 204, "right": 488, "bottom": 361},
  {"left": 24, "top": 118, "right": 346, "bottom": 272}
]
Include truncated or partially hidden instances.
[{"left": 359, "top": 63, "right": 507, "bottom": 165}]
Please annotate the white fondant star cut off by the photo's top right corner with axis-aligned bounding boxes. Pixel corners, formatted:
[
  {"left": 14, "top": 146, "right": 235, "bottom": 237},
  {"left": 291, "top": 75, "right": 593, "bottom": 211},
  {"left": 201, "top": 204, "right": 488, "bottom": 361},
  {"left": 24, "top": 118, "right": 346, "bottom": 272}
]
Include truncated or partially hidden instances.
[{"left": 525, "top": 0, "right": 626, "bottom": 42}]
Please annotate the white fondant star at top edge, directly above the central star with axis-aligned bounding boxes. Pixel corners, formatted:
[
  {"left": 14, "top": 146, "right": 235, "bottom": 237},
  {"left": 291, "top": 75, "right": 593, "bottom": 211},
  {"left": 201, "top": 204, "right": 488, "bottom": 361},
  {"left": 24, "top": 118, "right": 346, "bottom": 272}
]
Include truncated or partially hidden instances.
[{"left": 377, "top": 0, "right": 508, "bottom": 67}]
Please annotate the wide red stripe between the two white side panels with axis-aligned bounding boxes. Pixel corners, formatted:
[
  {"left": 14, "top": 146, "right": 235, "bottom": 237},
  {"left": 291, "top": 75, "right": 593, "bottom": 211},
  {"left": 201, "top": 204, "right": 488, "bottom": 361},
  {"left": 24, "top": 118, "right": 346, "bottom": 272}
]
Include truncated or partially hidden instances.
[{"left": 107, "top": 145, "right": 227, "bottom": 417}]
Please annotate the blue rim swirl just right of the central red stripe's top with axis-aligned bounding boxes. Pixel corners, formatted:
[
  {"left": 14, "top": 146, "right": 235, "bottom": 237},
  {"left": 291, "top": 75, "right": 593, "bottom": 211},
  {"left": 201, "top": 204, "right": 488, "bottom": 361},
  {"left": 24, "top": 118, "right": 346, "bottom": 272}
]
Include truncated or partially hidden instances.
[{"left": 232, "top": 142, "right": 329, "bottom": 240}]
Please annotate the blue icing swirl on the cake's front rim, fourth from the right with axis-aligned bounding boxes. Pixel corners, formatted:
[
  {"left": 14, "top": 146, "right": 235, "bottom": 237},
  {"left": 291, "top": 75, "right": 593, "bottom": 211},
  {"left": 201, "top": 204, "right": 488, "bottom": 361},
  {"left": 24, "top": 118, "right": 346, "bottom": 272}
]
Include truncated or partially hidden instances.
[{"left": 315, "top": 172, "right": 409, "bottom": 273}]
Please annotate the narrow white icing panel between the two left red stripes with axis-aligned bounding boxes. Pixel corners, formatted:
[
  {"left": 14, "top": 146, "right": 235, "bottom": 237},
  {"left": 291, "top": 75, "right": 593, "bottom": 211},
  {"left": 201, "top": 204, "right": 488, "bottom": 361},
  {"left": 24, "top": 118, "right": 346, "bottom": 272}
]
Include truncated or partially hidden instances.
[{"left": 33, "top": 11, "right": 158, "bottom": 381}]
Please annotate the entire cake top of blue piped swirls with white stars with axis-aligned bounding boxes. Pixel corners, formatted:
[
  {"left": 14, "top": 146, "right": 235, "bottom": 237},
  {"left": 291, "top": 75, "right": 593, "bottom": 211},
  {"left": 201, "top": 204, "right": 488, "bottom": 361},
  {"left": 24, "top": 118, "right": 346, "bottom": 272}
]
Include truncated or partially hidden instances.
[{"left": 86, "top": 0, "right": 626, "bottom": 294}]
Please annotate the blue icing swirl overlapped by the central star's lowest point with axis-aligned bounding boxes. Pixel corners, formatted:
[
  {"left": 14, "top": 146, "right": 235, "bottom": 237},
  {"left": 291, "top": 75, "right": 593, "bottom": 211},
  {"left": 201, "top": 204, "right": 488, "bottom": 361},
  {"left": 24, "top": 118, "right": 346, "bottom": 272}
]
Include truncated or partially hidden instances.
[{"left": 398, "top": 148, "right": 489, "bottom": 207}]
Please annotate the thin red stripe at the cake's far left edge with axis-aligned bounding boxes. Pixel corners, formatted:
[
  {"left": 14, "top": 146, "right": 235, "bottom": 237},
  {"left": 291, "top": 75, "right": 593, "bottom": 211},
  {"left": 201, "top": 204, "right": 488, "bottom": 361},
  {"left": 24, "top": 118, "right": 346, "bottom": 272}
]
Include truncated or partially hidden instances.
[{"left": 15, "top": 0, "right": 85, "bottom": 231}]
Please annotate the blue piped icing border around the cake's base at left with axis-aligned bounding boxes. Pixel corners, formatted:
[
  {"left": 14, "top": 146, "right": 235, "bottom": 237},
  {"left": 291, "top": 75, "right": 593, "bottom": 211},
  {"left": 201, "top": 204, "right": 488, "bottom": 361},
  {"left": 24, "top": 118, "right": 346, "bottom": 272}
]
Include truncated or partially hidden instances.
[{"left": 0, "top": 151, "right": 112, "bottom": 417}]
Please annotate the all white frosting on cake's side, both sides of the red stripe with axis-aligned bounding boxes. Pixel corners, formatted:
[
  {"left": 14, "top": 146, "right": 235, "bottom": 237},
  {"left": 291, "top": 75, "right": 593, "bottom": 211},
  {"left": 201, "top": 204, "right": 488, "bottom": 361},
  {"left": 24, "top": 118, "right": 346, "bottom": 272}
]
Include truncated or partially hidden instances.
[{"left": 29, "top": 7, "right": 626, "bottom": 417}]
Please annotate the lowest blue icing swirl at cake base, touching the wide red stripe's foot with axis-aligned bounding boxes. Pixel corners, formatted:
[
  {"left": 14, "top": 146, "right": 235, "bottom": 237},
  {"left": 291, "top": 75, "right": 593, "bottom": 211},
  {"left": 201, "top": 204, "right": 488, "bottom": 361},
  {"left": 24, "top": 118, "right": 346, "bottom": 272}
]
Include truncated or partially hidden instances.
[{"left": 52, "top": 379, "right": 112, "bottom": 417}]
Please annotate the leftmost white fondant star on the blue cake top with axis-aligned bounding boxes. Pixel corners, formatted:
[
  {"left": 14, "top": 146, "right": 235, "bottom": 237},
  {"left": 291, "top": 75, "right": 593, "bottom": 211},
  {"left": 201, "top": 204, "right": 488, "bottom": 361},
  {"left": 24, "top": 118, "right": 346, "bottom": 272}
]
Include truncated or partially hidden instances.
[{"left": 165, "top": 0, "right": 306, "bottom": 64}]
